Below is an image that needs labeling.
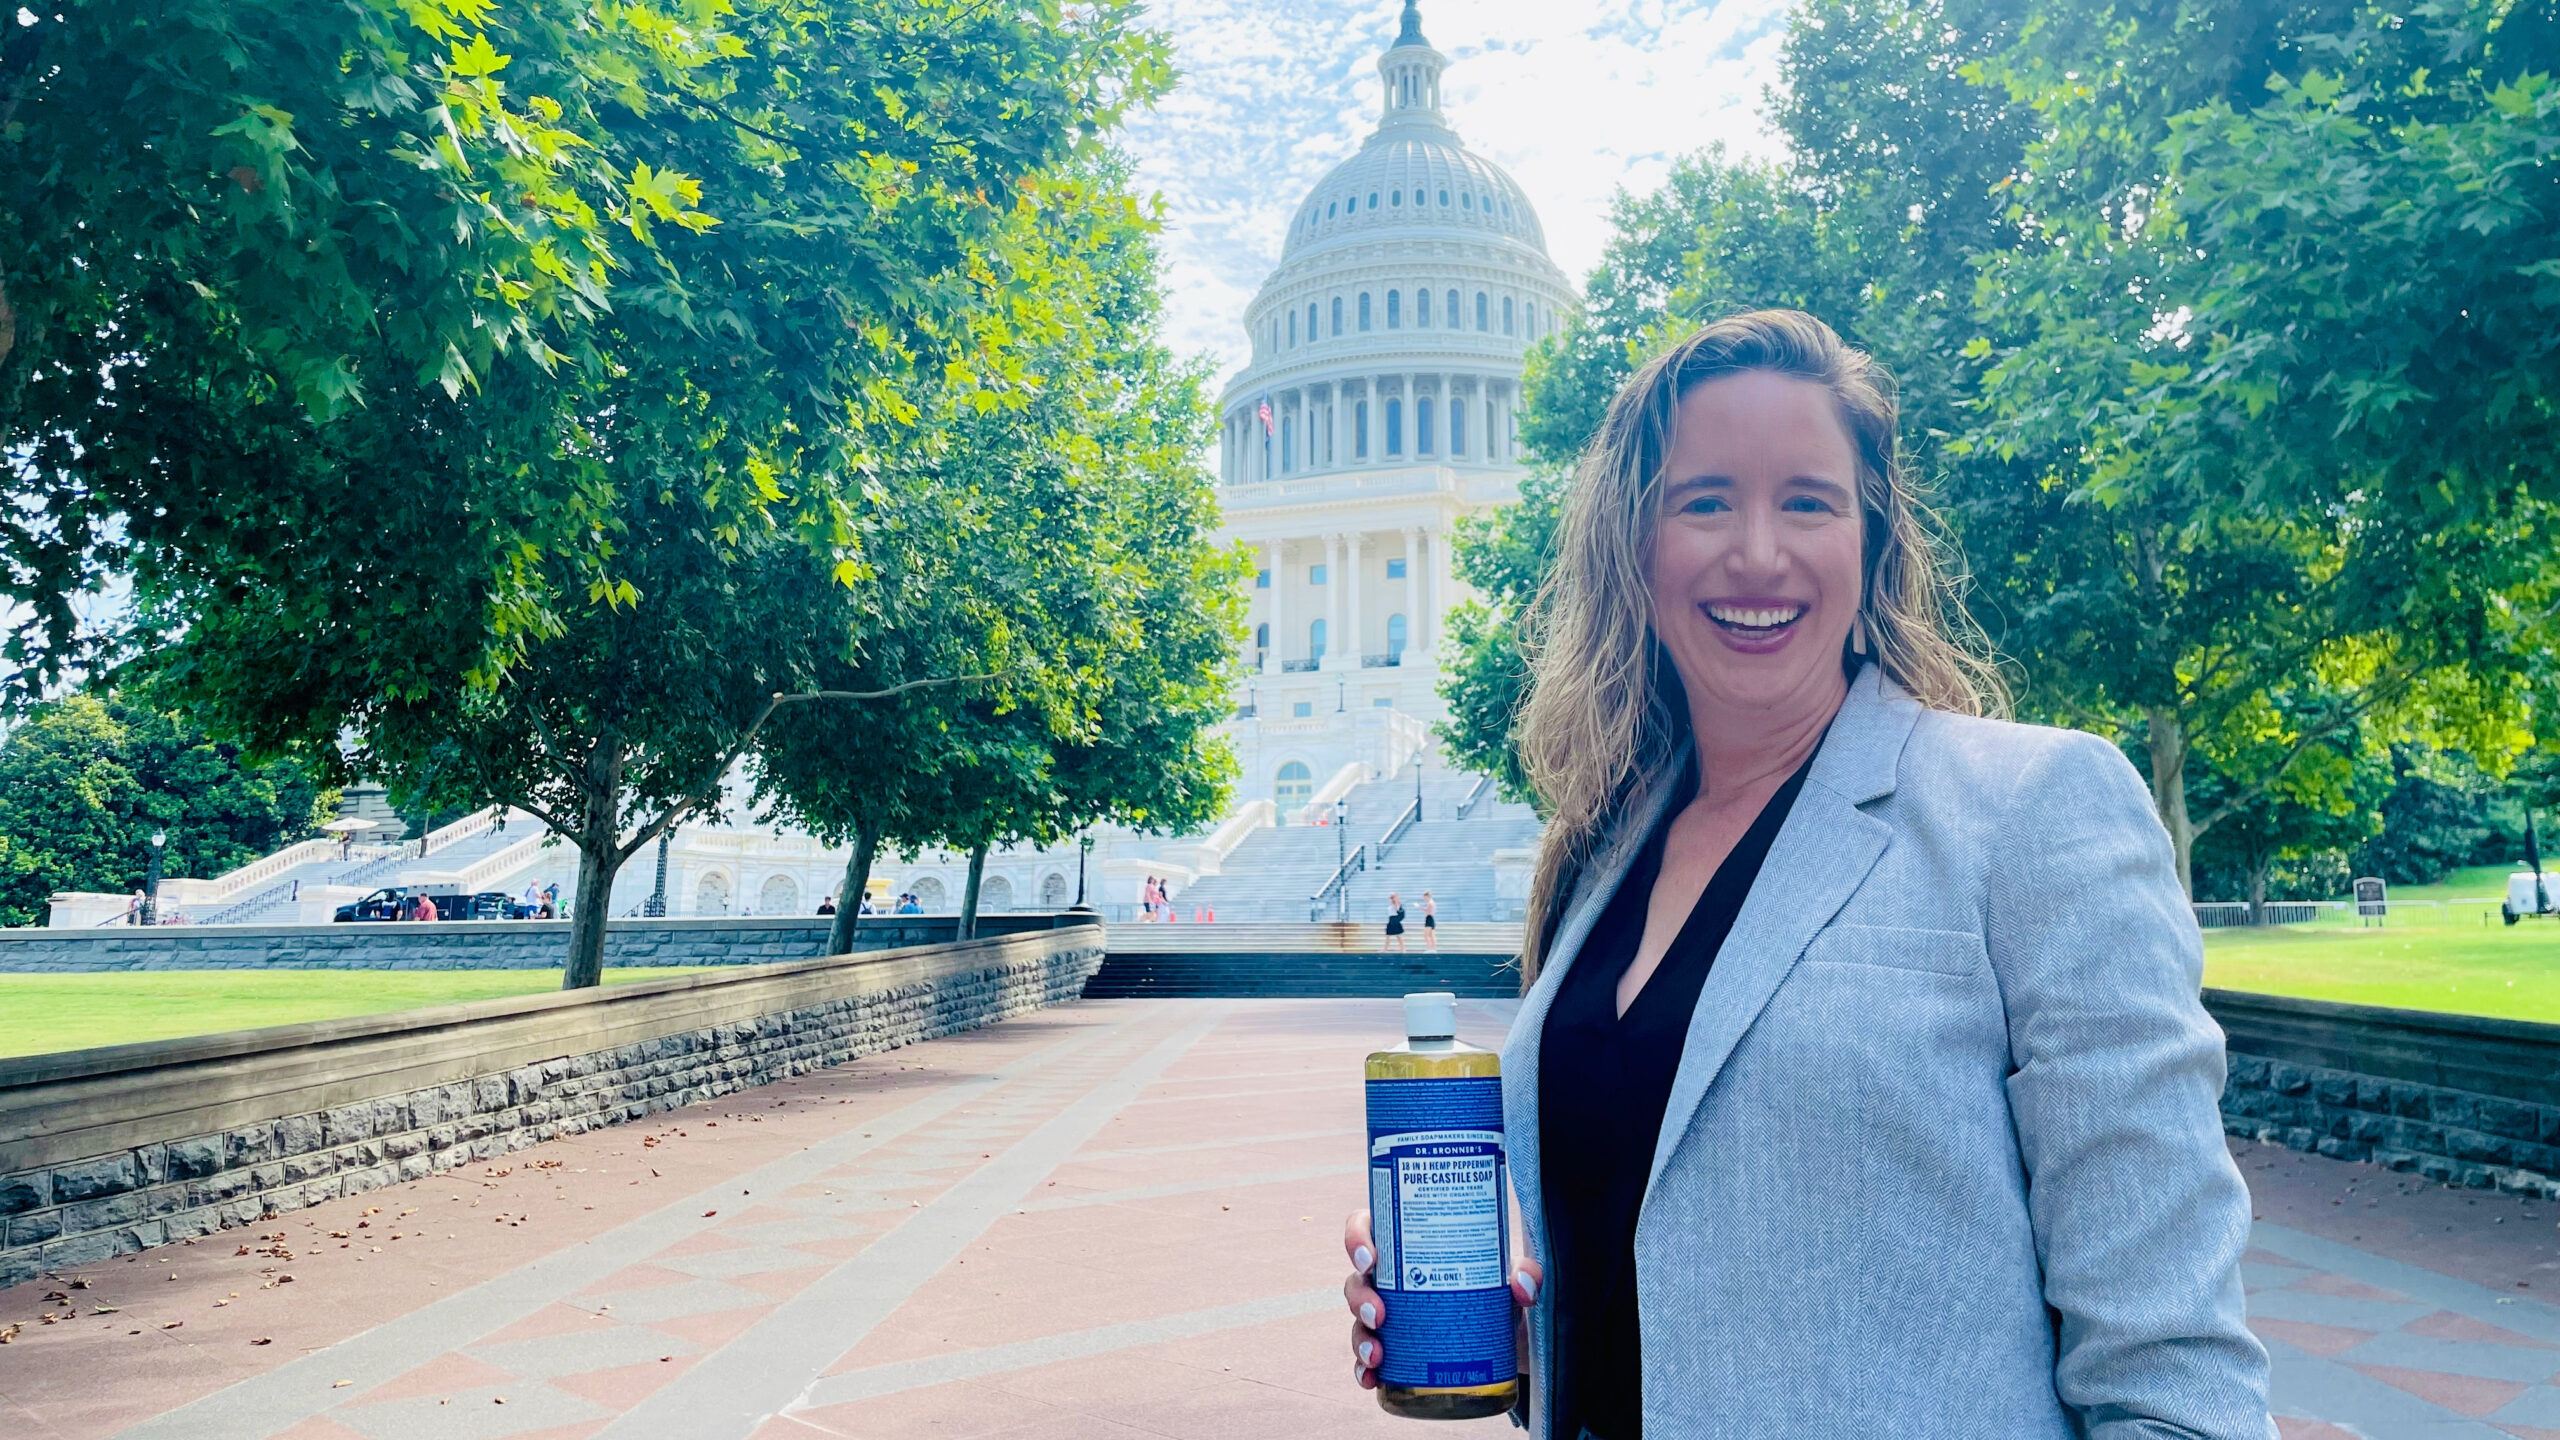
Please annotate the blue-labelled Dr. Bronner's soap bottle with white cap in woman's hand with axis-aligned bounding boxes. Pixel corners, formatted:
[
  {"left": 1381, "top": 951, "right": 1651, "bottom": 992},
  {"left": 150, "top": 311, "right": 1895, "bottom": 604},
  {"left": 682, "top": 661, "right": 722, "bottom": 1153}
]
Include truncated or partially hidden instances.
[{"left": 1367, "top": 992, "right": 1521, "bottom": 1420}]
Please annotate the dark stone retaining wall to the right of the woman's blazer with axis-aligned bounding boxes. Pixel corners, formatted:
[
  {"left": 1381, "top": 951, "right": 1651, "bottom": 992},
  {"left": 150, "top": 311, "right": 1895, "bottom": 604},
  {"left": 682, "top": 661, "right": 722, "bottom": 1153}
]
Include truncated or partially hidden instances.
[{"left": 2204, "top": 989, "right": 2560, "bottom": 1199}]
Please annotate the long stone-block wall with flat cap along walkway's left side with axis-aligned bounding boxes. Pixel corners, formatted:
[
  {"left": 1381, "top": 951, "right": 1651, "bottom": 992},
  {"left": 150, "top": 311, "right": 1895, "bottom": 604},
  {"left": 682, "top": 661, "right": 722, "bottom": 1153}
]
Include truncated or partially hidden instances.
[{"left": 0, "top": 925, "right": 1103, "bottom": 1286}]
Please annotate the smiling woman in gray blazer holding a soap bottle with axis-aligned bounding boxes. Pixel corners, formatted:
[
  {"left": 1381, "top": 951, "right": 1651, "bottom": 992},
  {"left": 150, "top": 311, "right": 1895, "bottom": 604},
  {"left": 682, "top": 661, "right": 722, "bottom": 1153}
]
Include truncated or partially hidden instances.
[{"left": 1344, "top": 310, "right": 2273, "bottom": 1440}]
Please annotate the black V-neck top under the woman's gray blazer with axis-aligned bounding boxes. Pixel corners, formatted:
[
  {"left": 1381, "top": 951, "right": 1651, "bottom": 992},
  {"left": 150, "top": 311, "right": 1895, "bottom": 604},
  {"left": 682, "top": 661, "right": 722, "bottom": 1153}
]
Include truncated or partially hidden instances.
[{"left": 1539, "top": 748, "right": 1820, "bottom": 1440}]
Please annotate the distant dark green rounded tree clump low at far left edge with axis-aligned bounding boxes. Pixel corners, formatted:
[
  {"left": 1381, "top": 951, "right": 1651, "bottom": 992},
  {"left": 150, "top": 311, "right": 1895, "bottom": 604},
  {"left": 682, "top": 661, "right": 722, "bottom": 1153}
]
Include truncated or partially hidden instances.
[{"left": 0, "top": 694, "right": 338, "bottom": 925}]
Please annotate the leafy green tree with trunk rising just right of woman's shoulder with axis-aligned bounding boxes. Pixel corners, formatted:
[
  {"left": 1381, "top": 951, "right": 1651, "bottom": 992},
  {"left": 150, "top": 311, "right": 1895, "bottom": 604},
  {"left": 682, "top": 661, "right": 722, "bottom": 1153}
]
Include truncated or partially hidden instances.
[{"left": 1958, "top": 0, "right": 2560, "bottom": 874}]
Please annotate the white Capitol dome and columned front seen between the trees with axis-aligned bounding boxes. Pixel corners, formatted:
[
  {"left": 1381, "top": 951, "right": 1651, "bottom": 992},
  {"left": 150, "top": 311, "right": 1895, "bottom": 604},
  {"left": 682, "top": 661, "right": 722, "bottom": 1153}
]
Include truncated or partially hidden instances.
[{"left": 1219, "top": 0, "right": 1577, "bottom": 822}]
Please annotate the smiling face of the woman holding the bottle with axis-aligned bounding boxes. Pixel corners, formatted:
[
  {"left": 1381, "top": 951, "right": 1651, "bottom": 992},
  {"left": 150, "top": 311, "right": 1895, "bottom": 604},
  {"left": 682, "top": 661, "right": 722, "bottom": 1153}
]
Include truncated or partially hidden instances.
[{"left": 1651, "top": 372, "right": 1864, "bottom": 712}]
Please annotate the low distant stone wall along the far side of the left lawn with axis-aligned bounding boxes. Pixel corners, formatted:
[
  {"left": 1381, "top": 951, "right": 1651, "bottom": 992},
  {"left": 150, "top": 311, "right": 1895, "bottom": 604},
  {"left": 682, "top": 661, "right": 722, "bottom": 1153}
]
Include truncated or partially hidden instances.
[{"left": 0, "top": 912, "right": 1055, "bottom": 974}]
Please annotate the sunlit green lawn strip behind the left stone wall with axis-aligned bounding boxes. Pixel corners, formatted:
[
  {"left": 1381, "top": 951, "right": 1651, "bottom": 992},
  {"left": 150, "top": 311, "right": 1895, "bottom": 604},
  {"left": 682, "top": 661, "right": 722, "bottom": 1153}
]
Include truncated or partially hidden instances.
[{"left": 0, "top": 966, "right": 704, "bottom": 1056}]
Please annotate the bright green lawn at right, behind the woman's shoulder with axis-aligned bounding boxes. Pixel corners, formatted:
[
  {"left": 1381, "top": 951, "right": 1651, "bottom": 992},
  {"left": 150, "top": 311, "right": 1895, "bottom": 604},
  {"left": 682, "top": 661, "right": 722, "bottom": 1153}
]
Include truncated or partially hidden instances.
[{"left": 2204, "top": 866, "right": 2560, "bottom": 1022}]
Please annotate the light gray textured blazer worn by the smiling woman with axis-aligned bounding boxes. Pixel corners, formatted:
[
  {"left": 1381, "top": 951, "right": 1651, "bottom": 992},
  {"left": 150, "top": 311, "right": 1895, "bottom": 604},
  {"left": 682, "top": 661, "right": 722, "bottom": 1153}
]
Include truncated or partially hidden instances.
[{"left": 1503, "top": 666, "right": 2273, "bottom": 1440}]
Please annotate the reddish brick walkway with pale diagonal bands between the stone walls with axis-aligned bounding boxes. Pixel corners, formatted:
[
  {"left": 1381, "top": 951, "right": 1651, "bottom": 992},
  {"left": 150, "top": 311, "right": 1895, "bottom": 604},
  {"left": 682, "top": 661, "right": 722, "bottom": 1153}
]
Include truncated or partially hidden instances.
[{"left": 0, "top": 1002, "right": 2560, "bottom": 1440}]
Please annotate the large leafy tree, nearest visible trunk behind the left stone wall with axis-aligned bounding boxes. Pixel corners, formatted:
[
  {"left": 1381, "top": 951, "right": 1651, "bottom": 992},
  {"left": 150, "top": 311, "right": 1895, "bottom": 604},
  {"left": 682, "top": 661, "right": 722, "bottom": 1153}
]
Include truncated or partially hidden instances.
[{"left": 138, "top": 0, "right": 1162, "bottom": 986}]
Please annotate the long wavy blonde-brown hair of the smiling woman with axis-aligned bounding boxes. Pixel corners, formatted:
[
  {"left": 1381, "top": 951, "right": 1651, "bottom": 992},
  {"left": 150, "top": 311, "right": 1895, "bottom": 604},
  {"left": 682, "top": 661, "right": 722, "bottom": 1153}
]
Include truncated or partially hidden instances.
[{"left": 1518, "top": 310, "right": 2010, "bottom": 989}]
